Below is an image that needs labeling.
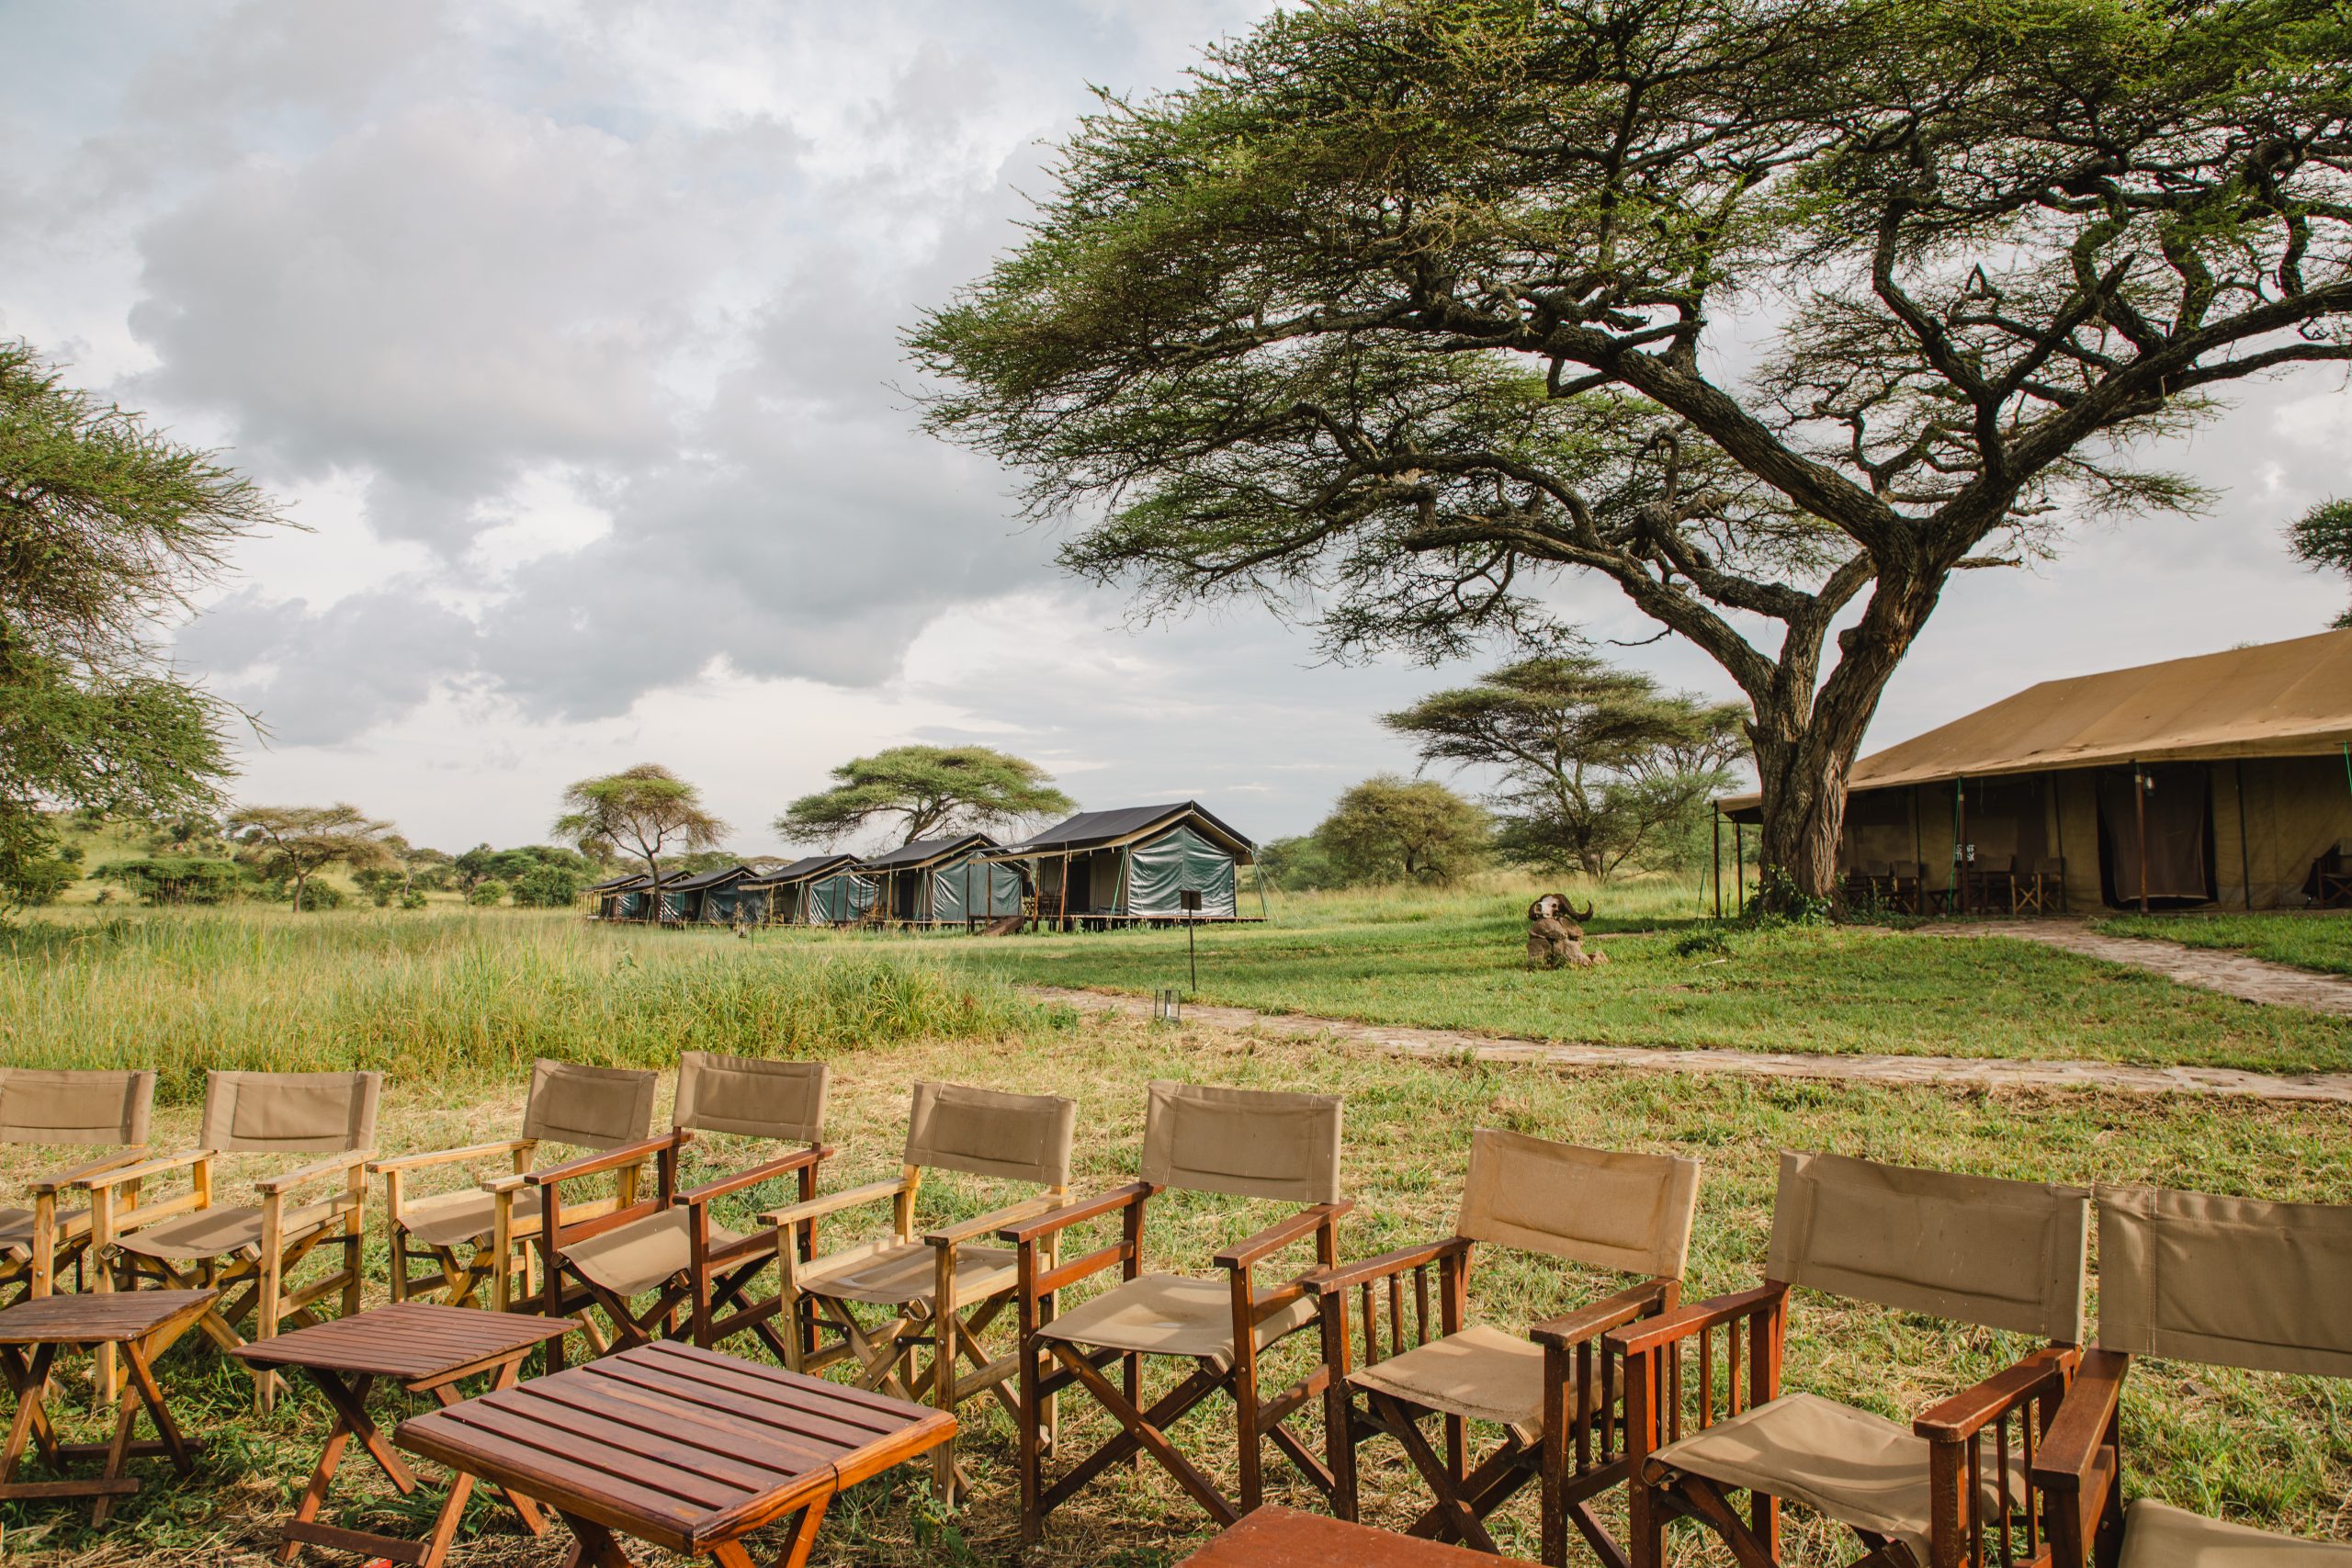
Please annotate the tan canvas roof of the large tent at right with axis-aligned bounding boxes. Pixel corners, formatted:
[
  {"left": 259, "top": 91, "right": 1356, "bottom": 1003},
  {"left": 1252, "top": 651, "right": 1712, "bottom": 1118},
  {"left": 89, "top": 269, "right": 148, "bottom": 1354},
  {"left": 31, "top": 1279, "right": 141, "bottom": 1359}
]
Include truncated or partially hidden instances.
[{"left": 1717, "top": 630, "right": 2352, "bottom": 811}]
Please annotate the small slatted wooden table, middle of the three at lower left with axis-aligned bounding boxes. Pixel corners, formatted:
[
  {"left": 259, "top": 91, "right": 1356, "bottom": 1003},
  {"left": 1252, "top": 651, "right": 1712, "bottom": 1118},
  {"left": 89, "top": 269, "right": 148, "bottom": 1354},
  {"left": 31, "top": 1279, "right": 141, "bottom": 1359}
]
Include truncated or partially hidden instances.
[{"left": 232, "top": 1303, "right": 571, "bottom": 1568}]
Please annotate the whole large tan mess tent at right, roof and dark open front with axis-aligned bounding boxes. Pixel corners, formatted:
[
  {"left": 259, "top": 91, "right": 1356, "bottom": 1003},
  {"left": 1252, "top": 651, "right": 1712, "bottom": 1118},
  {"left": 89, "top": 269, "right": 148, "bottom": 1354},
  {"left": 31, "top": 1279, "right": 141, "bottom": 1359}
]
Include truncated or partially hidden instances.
[{"left": 1717, "top": 630, "right": 2352, "bottom": 909}]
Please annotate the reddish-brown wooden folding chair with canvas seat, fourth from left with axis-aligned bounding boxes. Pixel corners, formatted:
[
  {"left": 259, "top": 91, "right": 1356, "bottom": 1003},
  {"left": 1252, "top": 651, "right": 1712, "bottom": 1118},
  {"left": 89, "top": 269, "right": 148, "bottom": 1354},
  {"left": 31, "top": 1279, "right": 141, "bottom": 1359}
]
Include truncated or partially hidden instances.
[{"left": 538, "top": 1051, "right": 832, "bottom": 1371}]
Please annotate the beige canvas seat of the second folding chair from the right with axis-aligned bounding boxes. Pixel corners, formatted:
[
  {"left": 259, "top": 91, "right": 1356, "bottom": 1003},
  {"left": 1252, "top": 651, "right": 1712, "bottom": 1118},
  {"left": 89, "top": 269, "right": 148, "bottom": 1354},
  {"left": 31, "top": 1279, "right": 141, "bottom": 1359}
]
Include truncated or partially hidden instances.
[{"left": 1651, "top": 1394, "right": 2028, "bottom": 1563}]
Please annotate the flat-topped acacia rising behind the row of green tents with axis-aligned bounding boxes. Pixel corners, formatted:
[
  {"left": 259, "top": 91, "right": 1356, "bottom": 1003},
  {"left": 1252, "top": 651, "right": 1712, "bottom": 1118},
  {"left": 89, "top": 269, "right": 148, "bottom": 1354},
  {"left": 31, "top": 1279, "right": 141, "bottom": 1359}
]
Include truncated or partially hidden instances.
[{"left": 776, "top": 745, "right": 1077, "bottom": 844}]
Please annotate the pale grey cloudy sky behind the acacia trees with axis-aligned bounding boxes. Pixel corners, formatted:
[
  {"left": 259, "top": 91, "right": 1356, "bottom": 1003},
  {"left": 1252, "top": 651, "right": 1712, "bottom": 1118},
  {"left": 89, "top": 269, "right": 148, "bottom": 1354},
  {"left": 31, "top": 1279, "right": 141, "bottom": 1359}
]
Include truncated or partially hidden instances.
[{"left": 0, "top": 0, "right": 2352, "bottom": 853}]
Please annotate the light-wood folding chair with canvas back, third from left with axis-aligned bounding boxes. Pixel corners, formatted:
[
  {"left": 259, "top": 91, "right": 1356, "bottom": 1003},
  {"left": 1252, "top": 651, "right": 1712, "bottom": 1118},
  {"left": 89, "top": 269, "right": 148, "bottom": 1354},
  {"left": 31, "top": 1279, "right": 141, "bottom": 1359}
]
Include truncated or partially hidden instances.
[{"left": 367, "top": 1058, "right": 661, "bottom": 1312}]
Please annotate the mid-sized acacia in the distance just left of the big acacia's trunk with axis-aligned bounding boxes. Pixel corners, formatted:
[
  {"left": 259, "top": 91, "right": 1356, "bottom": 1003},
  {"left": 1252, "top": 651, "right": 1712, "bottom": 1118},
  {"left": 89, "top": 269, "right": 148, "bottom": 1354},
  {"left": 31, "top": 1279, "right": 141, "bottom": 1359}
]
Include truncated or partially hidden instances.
[{"left": 1381, "top": 653, "right": 1747, "bottom": 879}]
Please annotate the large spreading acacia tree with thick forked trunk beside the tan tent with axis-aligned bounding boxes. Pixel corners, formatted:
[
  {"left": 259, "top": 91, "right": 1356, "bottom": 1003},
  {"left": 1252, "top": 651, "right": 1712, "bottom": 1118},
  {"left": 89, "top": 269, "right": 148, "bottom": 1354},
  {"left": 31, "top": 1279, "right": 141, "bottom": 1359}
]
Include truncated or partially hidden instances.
[{"left": 910, "top": 0, "right": 2352, "bottom": 894}]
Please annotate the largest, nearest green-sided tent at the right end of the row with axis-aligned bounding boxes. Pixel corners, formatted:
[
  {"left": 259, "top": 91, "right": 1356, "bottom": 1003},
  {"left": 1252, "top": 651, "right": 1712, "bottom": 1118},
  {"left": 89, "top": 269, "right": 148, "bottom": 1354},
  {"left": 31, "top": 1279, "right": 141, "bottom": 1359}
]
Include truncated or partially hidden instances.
[{"left": 990, "top": 799, "right": 1265, "bottom": 929}]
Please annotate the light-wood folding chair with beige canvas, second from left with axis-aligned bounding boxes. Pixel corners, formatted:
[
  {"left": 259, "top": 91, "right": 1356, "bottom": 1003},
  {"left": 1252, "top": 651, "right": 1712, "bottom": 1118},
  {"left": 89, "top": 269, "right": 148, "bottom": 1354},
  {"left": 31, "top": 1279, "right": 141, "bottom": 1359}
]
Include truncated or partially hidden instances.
[{"left": 83, "top": 1072, "right": 383, "bottom": 1413}]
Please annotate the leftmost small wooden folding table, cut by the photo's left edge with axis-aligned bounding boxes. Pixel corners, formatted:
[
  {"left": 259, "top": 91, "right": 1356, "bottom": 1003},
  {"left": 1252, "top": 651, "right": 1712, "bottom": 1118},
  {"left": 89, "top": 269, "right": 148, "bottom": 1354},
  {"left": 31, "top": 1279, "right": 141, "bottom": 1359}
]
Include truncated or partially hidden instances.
[{"left": 0, "top": 1291, "right": 217, "bottom": 1526}]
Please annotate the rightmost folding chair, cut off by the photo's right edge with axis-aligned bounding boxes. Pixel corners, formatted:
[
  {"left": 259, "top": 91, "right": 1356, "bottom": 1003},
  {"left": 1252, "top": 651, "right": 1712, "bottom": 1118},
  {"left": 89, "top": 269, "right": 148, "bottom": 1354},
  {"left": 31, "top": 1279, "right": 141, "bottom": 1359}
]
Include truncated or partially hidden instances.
[{"left": 2032, "top": 1187, "right": 2352, "bottom": 1568}]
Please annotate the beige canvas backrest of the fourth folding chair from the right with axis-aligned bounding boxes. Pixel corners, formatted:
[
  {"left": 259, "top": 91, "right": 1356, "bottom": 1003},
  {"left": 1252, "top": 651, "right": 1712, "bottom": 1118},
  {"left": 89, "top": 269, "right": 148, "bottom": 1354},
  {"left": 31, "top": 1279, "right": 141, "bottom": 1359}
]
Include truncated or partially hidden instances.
[{"left": 1143, "top": 1079, "right": 1340, "bottom": 1203}]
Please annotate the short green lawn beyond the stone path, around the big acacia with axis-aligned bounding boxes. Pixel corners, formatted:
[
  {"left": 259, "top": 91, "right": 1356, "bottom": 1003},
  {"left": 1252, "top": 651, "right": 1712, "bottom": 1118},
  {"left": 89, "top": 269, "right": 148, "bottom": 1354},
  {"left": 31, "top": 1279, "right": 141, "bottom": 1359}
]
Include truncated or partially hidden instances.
[{"left": 917, "top": 891, "right": 2352, "bottom": 1072}]
